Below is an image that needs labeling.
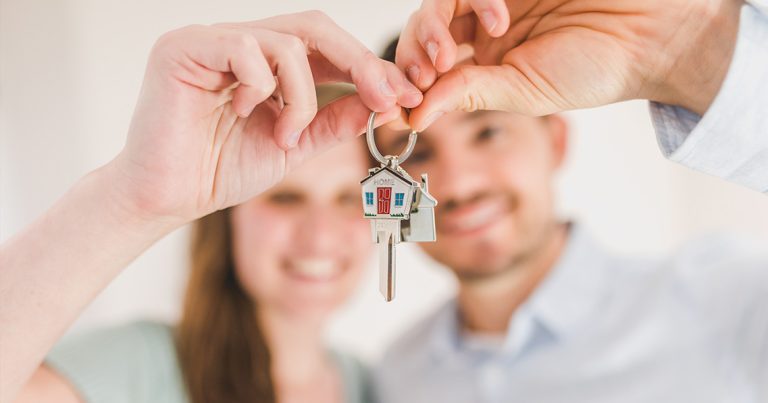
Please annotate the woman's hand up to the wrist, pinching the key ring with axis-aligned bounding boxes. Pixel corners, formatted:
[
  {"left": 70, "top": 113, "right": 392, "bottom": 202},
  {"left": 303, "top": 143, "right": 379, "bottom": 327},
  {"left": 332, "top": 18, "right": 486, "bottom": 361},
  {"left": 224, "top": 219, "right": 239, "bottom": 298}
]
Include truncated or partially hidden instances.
[{"left": 109, "top": 12, "right": 422, "bottom": 226}]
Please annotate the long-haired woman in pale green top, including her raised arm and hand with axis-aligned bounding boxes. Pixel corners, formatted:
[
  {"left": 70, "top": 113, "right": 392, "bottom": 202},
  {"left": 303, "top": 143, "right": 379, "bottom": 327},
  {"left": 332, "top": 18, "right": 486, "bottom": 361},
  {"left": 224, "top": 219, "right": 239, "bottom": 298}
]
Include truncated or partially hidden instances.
[{"left": 0, "top": 12, "right": 422, "bottom": 402}]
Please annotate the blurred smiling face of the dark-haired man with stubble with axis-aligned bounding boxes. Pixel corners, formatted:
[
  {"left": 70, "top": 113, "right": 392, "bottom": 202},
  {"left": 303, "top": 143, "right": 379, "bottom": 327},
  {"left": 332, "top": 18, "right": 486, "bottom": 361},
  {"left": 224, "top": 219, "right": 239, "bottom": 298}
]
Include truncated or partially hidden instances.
[{"left": 377, "top": 111, "right": 566, "bottom": 279}]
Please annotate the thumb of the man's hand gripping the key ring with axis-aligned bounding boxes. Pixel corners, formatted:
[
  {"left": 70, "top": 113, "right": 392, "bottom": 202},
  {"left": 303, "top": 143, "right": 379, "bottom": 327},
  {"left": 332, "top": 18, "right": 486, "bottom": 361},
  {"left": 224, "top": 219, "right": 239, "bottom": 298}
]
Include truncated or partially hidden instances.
[{"left": 409, "top": 64, "right": 559, "bottom": 131}]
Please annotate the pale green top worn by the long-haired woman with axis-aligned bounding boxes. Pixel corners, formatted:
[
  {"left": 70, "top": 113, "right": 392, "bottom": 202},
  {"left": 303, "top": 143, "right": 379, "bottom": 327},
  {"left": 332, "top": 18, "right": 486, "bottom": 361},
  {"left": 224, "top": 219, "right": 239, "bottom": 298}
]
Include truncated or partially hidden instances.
[{"left": 46, "top": 321, "right": 371, "bottom": 403}]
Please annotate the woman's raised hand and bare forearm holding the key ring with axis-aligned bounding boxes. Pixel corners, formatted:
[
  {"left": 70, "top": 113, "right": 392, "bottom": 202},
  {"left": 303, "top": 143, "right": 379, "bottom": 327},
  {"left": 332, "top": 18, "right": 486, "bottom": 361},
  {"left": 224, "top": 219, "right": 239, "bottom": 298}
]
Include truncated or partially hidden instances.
[{"left": 0, "top": 12, "right": 422, "bottom": 402}]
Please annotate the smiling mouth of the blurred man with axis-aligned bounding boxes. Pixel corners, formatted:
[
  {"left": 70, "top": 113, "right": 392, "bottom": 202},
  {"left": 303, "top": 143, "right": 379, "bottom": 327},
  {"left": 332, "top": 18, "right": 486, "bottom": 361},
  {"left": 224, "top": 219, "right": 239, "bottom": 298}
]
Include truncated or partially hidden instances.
[{"left": 437, "top": 198, "right": 507, "bottom": 236}]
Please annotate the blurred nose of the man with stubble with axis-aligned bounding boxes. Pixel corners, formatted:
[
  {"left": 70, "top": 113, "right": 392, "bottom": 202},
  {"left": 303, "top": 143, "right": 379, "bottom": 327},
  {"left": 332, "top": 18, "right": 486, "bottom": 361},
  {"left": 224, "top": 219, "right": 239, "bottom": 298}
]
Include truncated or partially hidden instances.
[{"left": 429, "top": 150, "right": 492, "bottom": 206}]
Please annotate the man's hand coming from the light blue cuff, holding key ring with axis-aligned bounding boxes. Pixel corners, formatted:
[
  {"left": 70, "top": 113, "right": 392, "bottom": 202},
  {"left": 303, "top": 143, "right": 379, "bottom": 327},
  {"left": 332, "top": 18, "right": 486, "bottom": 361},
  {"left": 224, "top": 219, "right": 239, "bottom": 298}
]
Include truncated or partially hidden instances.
[{"left": 396, "top": 0, "right": 742, "bottom": 130}]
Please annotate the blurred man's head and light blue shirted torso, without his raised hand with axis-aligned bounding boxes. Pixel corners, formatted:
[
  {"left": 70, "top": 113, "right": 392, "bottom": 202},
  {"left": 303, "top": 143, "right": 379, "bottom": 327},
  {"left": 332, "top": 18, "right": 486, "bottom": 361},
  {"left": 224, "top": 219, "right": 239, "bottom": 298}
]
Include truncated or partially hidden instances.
[{"left": 376, "top": 38, "right": 768, "bottom": 403}]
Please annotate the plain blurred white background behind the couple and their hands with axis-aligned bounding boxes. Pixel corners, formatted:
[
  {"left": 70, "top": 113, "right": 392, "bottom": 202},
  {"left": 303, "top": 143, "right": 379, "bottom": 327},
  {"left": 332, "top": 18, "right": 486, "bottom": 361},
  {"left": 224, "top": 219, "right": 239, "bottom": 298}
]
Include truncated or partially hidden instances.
[{"left": 0, "top": 0, "right": 768, "bottom": 359}]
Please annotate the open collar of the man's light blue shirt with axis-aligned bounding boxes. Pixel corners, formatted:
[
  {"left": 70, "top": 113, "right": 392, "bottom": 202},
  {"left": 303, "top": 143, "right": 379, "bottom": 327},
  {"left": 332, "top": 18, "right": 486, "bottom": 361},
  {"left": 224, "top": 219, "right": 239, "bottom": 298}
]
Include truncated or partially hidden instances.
[{"left": 430, "top": 224, "right": 608, "bottom": 359}]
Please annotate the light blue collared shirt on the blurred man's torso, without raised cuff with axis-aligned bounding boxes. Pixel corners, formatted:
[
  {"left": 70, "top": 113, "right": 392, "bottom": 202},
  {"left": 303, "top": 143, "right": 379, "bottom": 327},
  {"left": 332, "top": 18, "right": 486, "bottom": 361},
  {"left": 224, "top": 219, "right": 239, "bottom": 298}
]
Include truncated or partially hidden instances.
[{"left": 375, "top": 227, "right": 768, "bottom": 403}]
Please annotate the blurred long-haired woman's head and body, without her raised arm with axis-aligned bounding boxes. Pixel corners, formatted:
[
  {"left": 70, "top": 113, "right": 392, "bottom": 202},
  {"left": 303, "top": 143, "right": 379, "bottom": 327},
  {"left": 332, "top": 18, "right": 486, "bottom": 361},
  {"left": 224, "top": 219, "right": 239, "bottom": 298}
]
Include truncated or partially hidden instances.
[{"left": 19, "top": 87, "right": 378, "bottom": 403}]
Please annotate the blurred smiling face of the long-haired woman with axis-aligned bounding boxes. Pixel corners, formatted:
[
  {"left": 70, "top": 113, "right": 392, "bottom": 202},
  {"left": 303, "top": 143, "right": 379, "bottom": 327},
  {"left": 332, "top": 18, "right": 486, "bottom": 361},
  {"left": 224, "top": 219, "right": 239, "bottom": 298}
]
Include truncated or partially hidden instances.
[{"left": 231, "top": 141, "right": 372, "bottom": 318}]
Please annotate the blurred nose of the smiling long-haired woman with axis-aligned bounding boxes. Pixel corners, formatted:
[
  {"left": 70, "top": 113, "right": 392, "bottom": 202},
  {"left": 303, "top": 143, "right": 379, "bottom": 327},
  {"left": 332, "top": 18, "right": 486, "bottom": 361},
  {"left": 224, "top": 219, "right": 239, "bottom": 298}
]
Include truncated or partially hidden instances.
[{"left": 294, "top": 204, "right": 343, "bottom": 256}]
